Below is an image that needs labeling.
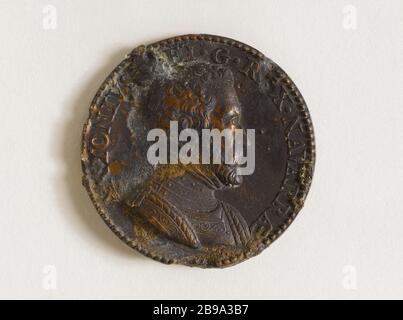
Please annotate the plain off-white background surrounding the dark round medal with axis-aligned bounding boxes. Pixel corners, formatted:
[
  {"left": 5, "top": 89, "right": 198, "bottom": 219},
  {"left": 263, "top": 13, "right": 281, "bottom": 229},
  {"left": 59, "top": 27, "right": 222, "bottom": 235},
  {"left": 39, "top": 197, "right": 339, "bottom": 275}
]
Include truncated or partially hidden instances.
[{"left": 0, "top": 0, "right": 403, "bottom": 299}]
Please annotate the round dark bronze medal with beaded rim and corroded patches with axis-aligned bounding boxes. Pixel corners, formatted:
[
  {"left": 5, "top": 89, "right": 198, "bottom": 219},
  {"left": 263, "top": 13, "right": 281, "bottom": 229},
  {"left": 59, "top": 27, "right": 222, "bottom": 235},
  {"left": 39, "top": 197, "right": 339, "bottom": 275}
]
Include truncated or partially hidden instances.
[{"left": 81, "top": 35, "right": 315, "bottom": 267}]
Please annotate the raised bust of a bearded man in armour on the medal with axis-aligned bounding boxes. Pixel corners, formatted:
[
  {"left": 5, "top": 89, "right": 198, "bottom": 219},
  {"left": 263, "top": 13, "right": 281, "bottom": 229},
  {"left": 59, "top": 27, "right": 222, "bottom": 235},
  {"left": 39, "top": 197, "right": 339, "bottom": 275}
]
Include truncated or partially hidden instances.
[{"left": 107, "top": 49, "right": 250, "bottom": 248}]
